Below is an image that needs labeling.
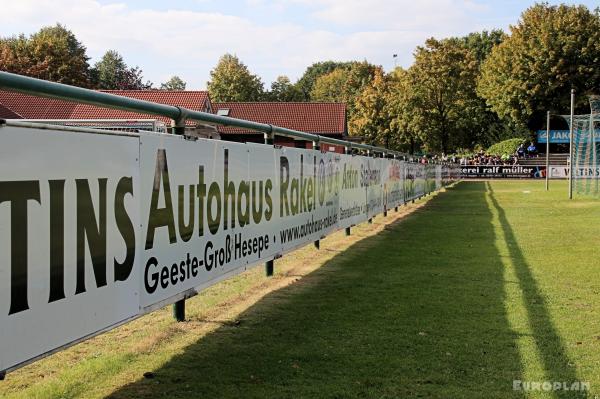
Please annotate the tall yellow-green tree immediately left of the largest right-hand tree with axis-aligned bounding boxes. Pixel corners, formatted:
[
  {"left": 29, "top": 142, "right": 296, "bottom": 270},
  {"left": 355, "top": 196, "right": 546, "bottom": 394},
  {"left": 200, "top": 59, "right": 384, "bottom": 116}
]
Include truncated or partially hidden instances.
[{"left": 408, "top": 38, "right": 478, "bottom": 153}]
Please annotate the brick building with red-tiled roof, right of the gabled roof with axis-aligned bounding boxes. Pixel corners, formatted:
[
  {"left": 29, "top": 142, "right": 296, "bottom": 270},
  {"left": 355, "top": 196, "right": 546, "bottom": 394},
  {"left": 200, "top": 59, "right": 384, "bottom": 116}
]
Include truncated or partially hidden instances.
[{"left": 212, "top": 102, "right": 348, "bottom": 152}]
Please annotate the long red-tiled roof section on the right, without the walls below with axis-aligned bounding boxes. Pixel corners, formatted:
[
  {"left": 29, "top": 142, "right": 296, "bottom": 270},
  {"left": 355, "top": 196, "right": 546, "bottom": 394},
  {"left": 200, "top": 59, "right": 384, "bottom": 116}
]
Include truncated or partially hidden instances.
[{"left": 212, "top": 102, "right": 346, "bottom": 135}]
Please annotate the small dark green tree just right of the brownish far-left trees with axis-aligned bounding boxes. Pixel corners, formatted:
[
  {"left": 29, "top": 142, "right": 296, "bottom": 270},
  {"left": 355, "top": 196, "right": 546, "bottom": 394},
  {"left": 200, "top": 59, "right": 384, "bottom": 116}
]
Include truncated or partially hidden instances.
[{"left": 92, "top": 50, "right": 152, "bottom": 90}]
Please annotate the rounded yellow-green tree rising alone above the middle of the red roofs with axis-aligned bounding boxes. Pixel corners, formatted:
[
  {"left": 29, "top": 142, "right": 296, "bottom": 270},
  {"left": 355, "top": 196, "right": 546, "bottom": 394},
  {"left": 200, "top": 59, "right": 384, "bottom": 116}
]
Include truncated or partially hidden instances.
[{"left": 206, "top": 54, "right": 263, "bottom": 102}]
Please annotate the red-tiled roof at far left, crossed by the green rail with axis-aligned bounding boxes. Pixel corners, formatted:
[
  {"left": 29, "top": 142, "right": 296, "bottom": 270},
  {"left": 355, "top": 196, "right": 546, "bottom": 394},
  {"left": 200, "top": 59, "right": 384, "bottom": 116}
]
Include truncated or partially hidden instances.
[{"left": 0, "top": 90, "right": 211, "bottom": 125}]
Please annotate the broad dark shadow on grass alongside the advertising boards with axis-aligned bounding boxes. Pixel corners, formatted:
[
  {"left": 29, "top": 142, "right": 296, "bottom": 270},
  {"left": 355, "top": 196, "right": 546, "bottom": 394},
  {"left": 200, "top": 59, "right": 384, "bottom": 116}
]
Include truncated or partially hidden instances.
[{"left": 111, "top": 183, "right": 524, "bottom": 398}]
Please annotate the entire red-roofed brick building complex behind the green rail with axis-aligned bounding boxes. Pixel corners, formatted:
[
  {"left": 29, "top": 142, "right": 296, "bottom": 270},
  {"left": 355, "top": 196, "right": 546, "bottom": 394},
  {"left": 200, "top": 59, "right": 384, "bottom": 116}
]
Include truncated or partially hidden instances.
[{"left": 0, "top": 90, "right": 347, "bottom": 152}]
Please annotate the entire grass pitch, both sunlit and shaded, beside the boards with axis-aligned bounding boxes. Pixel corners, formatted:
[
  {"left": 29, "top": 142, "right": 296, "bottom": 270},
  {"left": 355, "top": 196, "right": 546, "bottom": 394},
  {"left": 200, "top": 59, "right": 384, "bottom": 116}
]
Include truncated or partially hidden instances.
[{"left": 0, "top": 181, "right": 600, "bottom": 398}]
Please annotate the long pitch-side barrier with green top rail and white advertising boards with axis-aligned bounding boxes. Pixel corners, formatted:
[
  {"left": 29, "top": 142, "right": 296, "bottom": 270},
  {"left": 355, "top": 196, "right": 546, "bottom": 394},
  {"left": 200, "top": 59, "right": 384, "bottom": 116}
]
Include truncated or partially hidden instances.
[{"left": 0, "top": 72, "right": 459, "bottom": 378}]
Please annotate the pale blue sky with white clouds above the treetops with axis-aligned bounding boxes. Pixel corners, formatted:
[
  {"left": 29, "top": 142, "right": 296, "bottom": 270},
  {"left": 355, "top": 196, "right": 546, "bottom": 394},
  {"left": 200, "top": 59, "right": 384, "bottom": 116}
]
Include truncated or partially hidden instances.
[{"left": 0, "top": 0, "right": 600, "bottom": 90}]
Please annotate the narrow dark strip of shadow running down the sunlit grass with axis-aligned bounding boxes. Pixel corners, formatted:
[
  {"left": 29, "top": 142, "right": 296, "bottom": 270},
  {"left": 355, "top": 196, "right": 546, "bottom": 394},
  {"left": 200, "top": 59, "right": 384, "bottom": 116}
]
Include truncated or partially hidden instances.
[{"left": 486, "top": 183, "right": 587, "bottom": 398}]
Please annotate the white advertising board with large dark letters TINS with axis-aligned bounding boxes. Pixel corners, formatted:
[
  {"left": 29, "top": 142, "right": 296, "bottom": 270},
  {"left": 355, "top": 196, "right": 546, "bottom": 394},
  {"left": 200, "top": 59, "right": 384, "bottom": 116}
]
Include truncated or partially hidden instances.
[{"left": 0, "top": 126, "right": 141, "bottom": 371}]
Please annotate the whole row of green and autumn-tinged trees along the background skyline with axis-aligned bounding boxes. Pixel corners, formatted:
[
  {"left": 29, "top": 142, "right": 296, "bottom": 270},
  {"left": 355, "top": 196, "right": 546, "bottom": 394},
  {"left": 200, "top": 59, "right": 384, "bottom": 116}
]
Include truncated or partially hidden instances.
[{"left": 0, "top": 3, "right": 600, "bottom": 156}]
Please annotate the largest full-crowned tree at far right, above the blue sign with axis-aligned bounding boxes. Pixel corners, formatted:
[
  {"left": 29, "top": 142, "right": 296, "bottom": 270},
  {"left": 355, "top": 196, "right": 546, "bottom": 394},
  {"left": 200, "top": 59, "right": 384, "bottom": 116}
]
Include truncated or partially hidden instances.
[{"left": 477, "top": 3, "right": 600, "bottom": 129}]
